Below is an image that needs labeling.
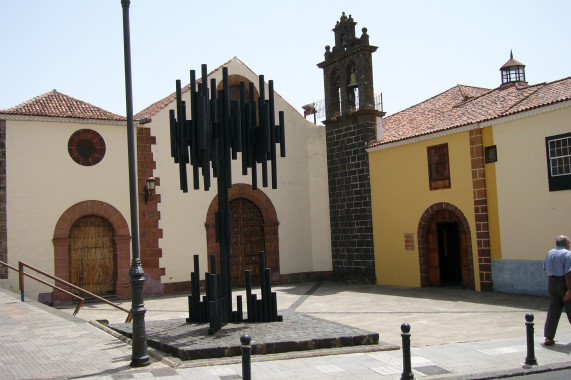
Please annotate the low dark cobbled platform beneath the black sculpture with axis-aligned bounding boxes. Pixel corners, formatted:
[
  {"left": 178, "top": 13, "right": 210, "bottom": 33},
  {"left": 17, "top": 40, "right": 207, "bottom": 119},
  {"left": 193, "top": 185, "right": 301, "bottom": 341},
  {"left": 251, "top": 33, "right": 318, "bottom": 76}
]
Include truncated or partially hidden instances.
[{"left": 108, "top": 312, "right": 398, "bottom": 360}]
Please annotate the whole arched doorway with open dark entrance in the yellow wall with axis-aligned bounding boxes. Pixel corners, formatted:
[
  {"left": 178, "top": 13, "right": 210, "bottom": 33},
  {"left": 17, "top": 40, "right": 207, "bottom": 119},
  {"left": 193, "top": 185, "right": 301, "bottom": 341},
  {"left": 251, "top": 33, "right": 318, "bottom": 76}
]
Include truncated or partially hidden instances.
[{"left": 418, "top": 203, "right": 474, "bottom": 289}]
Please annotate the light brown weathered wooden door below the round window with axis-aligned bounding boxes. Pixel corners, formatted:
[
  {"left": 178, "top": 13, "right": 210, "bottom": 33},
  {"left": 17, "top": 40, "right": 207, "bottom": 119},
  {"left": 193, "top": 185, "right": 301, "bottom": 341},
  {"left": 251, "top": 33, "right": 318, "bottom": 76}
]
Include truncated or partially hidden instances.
[{"left": 69, "top": 216, "right": 115, "bottom": 295}]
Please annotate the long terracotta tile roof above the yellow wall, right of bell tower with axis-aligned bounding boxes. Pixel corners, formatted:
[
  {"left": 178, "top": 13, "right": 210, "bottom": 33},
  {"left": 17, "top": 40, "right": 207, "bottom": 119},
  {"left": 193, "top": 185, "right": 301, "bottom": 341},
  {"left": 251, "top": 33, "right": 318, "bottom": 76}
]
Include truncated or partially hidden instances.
[{"left": 369, "top": 77, "right": 571, "bottom": 148}]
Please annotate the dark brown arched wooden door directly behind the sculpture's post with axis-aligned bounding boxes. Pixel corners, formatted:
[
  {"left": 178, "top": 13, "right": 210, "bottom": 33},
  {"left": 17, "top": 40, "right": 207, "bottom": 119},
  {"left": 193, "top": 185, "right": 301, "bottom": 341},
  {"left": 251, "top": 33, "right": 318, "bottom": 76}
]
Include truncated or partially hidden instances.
[{"left": 230, "top": 198, "right": 265, "bottom": 286}]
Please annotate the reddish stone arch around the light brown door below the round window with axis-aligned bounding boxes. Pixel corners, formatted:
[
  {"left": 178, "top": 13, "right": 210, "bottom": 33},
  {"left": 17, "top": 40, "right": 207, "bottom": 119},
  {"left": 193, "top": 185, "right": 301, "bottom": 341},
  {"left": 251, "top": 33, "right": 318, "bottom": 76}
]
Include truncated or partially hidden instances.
[{"left": 53, "top": 200, "right": 131, "bottom": 305}]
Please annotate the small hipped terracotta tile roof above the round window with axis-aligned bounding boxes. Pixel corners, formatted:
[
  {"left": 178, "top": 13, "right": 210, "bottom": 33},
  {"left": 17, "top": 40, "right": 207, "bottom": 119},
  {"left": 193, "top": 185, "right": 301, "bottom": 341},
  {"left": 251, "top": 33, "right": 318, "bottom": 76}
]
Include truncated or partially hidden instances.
[{"left": 0, "top": 90, "right": 126, "bottom": 121}]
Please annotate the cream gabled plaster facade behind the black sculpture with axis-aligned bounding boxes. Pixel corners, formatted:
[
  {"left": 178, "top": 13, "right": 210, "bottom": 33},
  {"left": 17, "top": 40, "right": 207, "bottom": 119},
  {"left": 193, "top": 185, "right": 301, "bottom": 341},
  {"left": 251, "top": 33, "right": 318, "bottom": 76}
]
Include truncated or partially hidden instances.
[{"left": 149, "top": 60, "right": 331, "bottom": 283}]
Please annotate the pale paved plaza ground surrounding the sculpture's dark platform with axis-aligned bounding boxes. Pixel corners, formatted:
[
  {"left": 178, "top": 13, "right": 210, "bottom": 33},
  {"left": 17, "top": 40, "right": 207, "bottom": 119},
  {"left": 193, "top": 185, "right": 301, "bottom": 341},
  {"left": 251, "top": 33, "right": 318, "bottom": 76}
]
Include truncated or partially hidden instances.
[{"left": 0, "top": 283, "right": 571, "bottom": 380}]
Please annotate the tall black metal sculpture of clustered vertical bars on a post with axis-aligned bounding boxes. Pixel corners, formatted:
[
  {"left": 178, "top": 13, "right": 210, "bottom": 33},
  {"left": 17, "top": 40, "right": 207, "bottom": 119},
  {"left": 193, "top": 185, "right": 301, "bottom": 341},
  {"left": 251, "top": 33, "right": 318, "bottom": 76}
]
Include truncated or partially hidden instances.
[{"left": 169, "top": 65, "right": 285, "bottom": 334}]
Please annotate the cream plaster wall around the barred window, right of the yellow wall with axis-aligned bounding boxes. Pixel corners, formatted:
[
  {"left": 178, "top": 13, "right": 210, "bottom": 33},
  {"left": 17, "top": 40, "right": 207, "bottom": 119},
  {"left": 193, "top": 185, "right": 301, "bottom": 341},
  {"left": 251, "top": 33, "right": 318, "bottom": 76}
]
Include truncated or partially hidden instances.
[{"left": 493, "top": 107, "right": 571, "bottom": 260}]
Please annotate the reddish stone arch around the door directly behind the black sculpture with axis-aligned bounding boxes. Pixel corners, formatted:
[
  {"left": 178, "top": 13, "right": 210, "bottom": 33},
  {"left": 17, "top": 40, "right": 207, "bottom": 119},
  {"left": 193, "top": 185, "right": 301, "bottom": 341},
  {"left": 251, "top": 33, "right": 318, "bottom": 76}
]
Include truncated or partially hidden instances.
[{"left": 204, "top": 183, "right": 280, "bottom": 281}]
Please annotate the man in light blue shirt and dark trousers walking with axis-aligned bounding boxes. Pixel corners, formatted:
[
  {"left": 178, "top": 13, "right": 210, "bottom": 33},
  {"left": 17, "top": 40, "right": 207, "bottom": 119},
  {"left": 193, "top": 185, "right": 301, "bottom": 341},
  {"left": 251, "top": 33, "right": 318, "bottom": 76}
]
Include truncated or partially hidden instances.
[{"left": 543, "top": 235, "right": 571, "bottom": 346}]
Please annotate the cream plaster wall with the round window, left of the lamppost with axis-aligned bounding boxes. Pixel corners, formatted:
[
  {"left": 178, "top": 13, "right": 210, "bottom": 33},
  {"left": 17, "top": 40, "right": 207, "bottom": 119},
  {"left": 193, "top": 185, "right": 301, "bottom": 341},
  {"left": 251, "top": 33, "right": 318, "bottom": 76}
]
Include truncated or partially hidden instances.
[{"left": 2, "top": 120, "right": 130, "bottom": 299}]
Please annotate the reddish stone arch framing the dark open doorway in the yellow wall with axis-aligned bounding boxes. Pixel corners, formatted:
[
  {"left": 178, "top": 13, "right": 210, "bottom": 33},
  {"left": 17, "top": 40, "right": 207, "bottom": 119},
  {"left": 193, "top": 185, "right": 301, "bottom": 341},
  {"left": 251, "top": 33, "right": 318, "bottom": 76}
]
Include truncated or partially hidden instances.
[{"left": 417, "top": 202, "right": 475, "bottom": 289}]
